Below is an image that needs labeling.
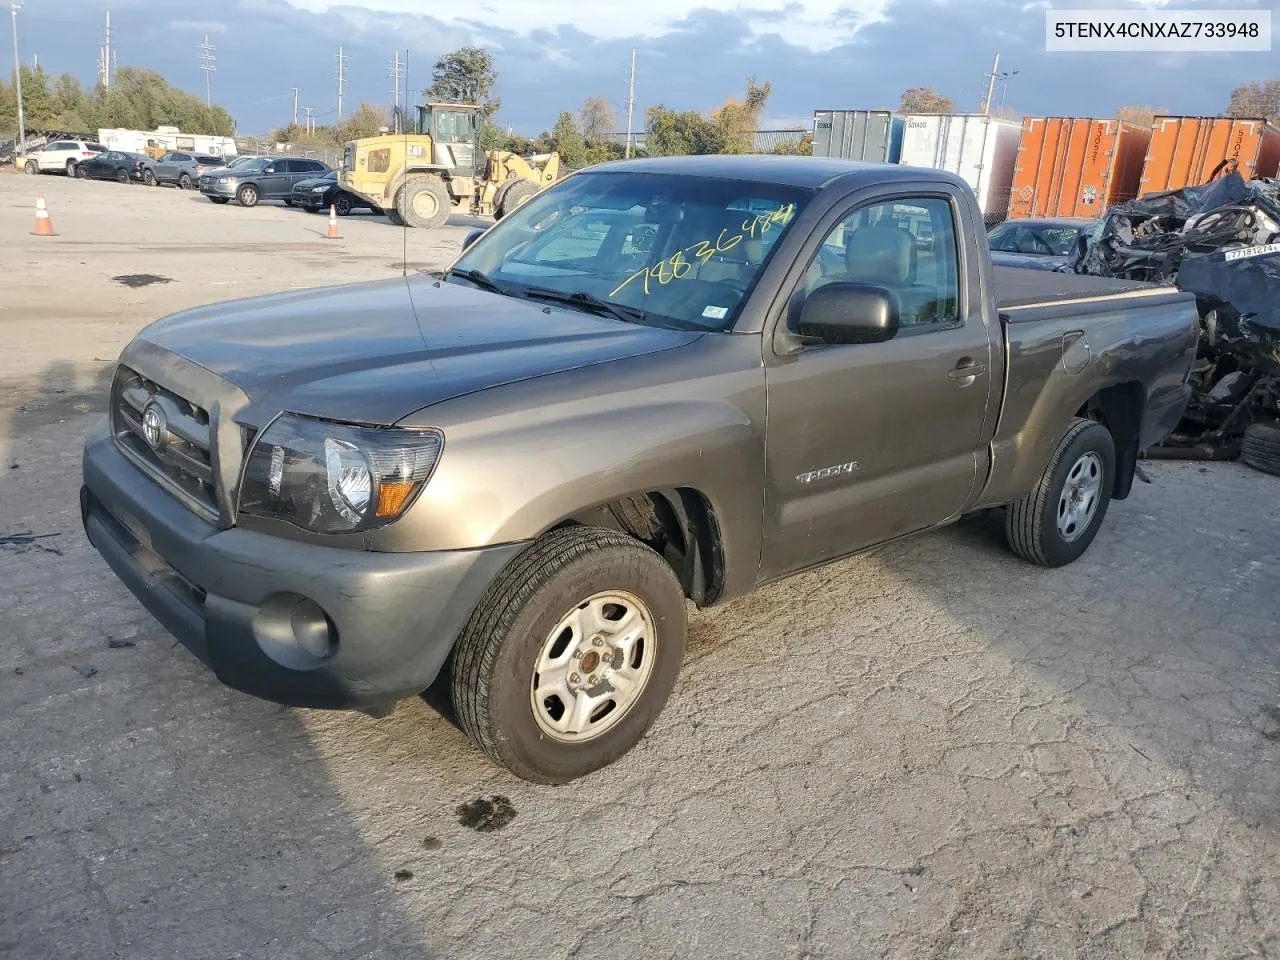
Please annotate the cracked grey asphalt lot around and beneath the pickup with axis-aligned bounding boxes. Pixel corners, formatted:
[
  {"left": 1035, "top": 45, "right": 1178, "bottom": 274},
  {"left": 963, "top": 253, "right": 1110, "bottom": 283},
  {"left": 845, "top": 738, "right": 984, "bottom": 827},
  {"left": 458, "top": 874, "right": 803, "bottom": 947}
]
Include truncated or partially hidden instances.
[{"left": 0, "top": 175, "right": 1280, "bottom": 960}]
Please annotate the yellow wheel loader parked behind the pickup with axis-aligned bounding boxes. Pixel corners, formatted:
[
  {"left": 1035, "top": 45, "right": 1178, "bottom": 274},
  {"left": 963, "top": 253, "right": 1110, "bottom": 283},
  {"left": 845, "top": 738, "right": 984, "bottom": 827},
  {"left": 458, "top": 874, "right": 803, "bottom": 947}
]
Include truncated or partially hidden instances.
[{"left": 338, "top": 104, "right": 561, "bottom": 228}]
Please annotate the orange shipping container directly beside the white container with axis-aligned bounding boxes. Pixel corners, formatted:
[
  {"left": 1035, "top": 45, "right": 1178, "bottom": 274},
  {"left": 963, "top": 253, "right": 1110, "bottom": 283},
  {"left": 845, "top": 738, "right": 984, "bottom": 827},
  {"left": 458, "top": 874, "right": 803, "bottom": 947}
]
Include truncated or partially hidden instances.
[{"left": 1009, "top": 116, "right": 1151, "bottom": 219}]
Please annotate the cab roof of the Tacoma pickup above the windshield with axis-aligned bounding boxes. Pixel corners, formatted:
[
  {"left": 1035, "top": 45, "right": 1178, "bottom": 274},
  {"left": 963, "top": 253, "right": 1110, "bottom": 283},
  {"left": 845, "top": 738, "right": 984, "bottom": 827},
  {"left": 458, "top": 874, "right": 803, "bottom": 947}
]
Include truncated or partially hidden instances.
[{"left": 590, "top": 154, "right": 964, "bottom": 189}]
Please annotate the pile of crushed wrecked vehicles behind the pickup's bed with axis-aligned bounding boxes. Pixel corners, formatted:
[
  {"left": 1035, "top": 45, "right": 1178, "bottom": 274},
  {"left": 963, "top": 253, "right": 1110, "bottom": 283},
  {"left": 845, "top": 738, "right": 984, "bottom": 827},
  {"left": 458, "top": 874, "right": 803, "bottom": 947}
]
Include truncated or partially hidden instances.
[{"left": 1068, "top": 170, "right": 1280, "bottom": 475}]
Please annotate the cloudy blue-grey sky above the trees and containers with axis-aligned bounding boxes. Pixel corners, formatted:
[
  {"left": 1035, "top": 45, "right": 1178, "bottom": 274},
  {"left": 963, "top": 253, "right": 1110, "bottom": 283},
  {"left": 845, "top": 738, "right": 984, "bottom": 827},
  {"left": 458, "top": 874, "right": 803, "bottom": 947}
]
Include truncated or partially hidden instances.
[{"left": 10, "top": 0, "right": 1280, "bottom": 134}]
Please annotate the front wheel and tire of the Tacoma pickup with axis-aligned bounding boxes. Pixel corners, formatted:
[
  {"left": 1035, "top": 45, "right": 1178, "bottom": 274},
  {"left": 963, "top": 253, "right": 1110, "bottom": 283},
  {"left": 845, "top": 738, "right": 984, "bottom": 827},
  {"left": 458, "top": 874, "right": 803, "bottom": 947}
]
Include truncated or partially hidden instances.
[{"left": 451, "top": 526, "right": 687, "bottom": 783}]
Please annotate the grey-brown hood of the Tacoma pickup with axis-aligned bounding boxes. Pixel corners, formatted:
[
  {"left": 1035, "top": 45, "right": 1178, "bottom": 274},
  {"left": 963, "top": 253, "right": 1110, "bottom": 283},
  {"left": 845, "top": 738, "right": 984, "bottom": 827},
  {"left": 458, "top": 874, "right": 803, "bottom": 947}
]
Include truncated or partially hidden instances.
[{"left": 138, "top": 275, "right": 701, "bottom": 425}]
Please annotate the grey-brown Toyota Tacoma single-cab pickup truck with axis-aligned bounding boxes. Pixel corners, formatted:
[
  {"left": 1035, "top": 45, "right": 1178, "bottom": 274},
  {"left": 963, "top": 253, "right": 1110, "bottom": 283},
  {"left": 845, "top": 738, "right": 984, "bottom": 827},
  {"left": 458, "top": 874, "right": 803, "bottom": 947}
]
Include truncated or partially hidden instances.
[{"left": 81, "top": 156, "right": 1199, "bottom": 783}]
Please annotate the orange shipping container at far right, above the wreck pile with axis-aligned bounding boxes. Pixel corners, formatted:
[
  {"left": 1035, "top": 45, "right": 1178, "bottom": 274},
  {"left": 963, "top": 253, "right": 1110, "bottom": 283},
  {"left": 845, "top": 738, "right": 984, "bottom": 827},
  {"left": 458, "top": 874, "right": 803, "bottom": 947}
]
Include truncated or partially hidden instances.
[{"left": 1140, "top": 116, "right": 1280, "bottom": 195}]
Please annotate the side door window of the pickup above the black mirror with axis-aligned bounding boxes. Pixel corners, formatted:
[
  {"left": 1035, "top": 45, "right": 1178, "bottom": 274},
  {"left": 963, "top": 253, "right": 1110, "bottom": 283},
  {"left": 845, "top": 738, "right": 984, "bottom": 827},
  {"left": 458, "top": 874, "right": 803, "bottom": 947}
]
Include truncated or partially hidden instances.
[{"left": 804, "top": 197, "right": 960, "bottom": 330}]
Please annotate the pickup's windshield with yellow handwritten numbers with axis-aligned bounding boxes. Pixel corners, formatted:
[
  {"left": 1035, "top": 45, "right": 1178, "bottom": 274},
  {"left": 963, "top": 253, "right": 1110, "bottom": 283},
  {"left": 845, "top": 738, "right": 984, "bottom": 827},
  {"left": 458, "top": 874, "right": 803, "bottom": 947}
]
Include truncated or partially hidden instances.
[{"left": 451, "top": 172, "right": 812, "bottom": 330}]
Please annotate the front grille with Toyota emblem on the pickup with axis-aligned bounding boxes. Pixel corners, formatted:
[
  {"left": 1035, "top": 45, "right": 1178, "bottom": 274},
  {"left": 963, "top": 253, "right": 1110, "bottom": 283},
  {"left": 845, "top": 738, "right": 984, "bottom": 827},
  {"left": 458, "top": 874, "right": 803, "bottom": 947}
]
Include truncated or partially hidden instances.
[{"left": 111, "top": 366, "right": 218, "bottom": 522}]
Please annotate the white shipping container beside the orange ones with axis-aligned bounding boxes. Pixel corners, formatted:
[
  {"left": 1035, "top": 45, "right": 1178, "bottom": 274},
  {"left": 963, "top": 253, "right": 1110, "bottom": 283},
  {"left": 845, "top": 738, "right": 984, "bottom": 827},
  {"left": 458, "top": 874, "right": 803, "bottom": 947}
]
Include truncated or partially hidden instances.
[{"left": 901, "top": 114, "right": 1023, "bottom": 227}]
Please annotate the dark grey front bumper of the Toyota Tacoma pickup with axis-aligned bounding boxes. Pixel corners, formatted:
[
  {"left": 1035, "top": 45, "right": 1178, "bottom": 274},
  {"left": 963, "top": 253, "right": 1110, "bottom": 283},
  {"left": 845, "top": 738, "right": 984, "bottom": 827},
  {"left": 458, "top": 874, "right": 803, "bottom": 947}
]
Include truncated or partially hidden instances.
[{"left": 81, "top": 425, "right": 525, "bottom": 709}]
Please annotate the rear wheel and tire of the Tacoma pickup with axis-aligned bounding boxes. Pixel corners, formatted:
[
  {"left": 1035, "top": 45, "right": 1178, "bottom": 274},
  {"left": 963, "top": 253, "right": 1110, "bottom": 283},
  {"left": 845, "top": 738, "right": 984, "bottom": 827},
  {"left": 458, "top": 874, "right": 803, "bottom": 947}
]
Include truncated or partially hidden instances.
[{"left": 1005, "top": 417, "right": 1116, "bottom": 567}]
